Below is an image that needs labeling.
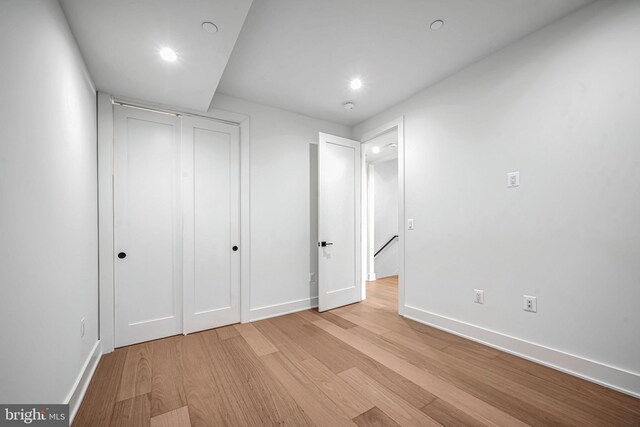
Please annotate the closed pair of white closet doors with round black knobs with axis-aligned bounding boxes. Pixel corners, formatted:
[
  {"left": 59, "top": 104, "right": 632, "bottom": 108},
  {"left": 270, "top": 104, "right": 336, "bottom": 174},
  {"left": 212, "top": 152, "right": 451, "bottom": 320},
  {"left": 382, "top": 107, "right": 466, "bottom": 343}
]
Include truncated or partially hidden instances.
[{"left": 113, "top": 106, "right": 240, "bottom": 347}]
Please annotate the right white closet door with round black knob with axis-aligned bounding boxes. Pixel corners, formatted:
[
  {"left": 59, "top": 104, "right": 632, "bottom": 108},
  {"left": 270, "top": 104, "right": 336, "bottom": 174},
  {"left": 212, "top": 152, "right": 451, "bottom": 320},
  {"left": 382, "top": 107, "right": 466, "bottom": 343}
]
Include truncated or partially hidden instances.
[{"left": 182, "top": 117, "right": 240, "bottom": 333}]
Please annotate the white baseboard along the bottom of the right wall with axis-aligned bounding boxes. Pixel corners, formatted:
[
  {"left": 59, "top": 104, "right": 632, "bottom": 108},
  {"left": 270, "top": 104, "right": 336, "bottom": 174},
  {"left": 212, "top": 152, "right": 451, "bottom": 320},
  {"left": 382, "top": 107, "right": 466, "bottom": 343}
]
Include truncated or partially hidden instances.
[{"left": 403, "top": 305, "right": 640, "bottom": 398}]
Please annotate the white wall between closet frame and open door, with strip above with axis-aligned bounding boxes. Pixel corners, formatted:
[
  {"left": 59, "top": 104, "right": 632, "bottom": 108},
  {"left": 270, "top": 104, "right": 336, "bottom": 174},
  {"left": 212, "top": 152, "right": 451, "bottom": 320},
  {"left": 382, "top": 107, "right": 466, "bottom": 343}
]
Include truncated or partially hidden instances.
[{"left": 211, "top": 94, "right": 350, "bottom": 319}]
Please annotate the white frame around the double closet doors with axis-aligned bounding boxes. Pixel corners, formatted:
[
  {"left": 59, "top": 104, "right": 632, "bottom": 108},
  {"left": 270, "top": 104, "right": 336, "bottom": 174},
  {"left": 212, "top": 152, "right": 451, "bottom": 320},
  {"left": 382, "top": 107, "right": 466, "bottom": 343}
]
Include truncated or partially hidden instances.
[{"left": 97, "top": 92, "right": 251, "bottom": 354}]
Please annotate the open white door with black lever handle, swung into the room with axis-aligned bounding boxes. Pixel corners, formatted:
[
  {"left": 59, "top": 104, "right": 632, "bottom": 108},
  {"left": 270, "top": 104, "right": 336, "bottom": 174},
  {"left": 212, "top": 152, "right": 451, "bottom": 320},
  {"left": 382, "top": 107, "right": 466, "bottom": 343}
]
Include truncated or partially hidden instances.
[{"left": 318, "top": 133, "right": 362, "bottom": 311}]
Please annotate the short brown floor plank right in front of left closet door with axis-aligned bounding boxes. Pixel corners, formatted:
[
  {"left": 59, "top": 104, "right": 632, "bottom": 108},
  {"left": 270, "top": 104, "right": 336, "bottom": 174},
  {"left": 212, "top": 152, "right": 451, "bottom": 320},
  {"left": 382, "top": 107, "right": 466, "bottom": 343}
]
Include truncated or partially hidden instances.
[{"left": 116, "top": 342, "right": 153, "bottom": 401}]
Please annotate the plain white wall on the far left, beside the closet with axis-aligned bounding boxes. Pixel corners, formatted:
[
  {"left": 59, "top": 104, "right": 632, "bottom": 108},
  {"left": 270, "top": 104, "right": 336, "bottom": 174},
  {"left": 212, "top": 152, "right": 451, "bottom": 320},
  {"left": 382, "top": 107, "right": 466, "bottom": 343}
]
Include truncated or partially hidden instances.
[{"left": 0, "top": 0, "right": 98, "bottom": 403}]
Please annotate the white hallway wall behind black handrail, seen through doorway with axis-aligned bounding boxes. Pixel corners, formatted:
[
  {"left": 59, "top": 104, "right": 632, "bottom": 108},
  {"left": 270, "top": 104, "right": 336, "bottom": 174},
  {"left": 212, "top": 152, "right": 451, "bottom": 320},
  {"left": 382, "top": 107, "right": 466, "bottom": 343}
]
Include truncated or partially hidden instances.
[{"left": 373, "top": 158, "right": 398, "bottom": 279}]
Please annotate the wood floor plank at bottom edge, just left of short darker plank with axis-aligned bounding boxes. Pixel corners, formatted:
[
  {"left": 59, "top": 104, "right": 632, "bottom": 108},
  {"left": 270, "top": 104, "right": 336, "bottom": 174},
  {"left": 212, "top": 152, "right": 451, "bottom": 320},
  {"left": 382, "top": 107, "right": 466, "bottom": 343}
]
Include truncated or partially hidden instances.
[{"left": 261, "top": 352, "right": 355, "bottom": 426}]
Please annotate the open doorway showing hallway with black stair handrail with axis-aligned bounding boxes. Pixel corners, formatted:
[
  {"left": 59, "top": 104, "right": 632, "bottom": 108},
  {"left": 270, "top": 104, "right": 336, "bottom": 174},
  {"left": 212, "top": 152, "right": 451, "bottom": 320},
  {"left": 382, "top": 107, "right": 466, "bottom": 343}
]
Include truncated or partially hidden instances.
[{"left": 362, "top": 126, "right": 403, "bottom": 312}]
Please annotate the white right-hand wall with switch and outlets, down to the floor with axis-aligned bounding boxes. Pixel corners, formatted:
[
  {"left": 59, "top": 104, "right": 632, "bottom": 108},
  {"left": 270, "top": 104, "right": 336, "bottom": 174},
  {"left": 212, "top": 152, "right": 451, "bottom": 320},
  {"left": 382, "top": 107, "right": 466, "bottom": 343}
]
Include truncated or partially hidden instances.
[{"left": 354, "top": 1, "right": 640, "bottom": 394}]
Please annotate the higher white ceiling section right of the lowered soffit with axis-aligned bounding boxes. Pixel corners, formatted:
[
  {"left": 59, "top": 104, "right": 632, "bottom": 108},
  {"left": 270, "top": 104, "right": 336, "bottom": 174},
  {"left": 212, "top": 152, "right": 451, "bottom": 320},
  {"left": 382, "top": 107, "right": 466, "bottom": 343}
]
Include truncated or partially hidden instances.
[{"left": 218, "top": 0, "right": 591, "bottom": 125}]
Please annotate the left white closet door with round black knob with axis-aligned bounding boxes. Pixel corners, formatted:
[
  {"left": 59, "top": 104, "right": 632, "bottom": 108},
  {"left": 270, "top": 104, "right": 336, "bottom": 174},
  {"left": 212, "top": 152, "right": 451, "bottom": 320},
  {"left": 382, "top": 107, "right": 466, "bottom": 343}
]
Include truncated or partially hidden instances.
[{"left": 113, "top": 106, "right": 182, "bottom": 347}]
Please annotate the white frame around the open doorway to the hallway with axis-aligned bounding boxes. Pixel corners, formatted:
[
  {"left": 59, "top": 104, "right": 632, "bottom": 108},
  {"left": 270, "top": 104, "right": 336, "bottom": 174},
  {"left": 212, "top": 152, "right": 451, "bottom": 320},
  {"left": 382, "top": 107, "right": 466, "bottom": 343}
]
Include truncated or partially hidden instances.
[{"left": 360, "top": 116, "right": 406, "bottom": 315}]
